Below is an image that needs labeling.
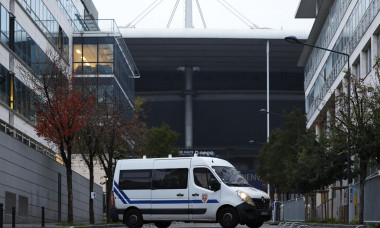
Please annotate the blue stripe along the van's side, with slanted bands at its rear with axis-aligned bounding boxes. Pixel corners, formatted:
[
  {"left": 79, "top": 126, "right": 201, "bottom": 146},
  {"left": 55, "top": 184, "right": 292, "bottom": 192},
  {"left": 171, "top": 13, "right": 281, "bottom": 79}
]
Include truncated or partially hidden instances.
[{"left": 114, "top": 181, "right": 219, "bottom": 204}]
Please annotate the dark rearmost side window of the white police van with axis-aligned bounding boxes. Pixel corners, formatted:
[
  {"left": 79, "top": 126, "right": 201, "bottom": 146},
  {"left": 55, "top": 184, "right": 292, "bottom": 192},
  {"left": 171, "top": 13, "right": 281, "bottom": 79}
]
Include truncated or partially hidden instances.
[{"left": 119, "top": 169, "right": 152, "bottom": 190}]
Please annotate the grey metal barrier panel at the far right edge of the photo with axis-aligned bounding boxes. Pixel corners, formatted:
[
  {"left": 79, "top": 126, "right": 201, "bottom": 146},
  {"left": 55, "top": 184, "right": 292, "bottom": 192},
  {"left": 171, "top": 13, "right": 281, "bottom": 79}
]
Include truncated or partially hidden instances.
[{"left": 364, "top": 174, "right": 380, "bottom": 223}]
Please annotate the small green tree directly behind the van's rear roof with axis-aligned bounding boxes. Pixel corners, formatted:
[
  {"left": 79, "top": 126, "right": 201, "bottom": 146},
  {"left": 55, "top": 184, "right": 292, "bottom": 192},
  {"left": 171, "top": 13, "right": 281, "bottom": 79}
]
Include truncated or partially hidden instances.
[{"left": 144, "top": 123, "right": 179, "bottom": 158}]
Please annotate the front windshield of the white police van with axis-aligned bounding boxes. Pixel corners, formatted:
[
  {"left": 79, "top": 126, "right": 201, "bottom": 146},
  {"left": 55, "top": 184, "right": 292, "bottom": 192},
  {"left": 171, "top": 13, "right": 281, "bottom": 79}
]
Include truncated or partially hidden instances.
[{"left": 212, "top": 166, "right": 251, "bottom": 187}]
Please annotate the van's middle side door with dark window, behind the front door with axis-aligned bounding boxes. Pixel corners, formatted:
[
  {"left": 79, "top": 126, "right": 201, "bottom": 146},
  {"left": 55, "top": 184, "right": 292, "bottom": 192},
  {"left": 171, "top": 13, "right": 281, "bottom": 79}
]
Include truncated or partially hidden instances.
[{"left": 152, "top": 159, "right": 190, "bottom": 220}]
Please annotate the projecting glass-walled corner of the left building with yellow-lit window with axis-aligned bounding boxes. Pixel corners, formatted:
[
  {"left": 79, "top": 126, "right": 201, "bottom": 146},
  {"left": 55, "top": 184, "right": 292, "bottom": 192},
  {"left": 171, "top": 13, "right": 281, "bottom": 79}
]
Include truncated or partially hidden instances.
[{"left": 73, "top": 37, "right": 134, "bottom": 110}]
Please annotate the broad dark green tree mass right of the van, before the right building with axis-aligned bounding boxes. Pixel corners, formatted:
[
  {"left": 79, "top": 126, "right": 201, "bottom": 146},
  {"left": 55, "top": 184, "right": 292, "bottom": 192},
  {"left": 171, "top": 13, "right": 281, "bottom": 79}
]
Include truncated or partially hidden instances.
[{"left": 257, "top": 110, "right": 346, "bottom": 193}]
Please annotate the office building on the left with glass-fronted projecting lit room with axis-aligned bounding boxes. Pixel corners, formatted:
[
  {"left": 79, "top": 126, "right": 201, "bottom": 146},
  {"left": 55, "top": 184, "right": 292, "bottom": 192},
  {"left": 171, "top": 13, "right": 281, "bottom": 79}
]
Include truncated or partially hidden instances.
[{"left": 0, "top": 0, "right": 138, "bottom": 223}]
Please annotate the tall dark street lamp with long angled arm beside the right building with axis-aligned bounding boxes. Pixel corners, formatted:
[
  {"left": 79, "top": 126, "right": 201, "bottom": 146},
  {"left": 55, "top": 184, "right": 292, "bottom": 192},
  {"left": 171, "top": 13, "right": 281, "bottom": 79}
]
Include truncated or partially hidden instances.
[{"left": 285, "top": 36, "right": 352, "bottom": 184}]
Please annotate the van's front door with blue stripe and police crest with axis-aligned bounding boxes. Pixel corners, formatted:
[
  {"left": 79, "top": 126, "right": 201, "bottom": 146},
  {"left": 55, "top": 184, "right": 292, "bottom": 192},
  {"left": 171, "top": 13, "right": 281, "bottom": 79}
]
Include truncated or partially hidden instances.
[{"left": 189, "top": 167, "right": 221, "bottom": 221}]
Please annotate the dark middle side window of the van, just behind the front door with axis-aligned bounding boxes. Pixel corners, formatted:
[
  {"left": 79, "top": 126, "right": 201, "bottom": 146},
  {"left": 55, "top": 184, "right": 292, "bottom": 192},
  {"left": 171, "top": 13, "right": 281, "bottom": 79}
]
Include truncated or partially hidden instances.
[{"left": 152, "top": 169, "right": 189, "bottom": 189}]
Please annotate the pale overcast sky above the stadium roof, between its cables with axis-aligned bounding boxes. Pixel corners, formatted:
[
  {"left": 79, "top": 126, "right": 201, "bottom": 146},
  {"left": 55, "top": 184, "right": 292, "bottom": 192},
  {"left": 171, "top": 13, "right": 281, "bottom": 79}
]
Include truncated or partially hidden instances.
[{"left": 93, "top": 0, "right": 314, "bottom": 31}]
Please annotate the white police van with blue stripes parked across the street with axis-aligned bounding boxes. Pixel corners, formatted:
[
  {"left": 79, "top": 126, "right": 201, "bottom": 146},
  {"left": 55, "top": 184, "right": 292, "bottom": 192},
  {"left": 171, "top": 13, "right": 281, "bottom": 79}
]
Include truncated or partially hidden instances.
[{"left": 112, "top": 156, "right": 272, "bottom": 228}]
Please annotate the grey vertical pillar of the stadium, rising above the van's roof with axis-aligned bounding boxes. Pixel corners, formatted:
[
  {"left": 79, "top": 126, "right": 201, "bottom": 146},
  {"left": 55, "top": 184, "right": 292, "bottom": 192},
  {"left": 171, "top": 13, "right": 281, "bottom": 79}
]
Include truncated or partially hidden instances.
[{"left": 185, "top": 67, "right": 193, "bottom": 148}]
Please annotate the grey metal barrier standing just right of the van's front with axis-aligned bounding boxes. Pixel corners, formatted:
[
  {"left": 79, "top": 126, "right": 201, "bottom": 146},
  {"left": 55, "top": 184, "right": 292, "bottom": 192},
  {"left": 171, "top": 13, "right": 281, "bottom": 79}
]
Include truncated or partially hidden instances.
[{"left": 283, "top": 198, "right": 305, "bottom": 221}]
